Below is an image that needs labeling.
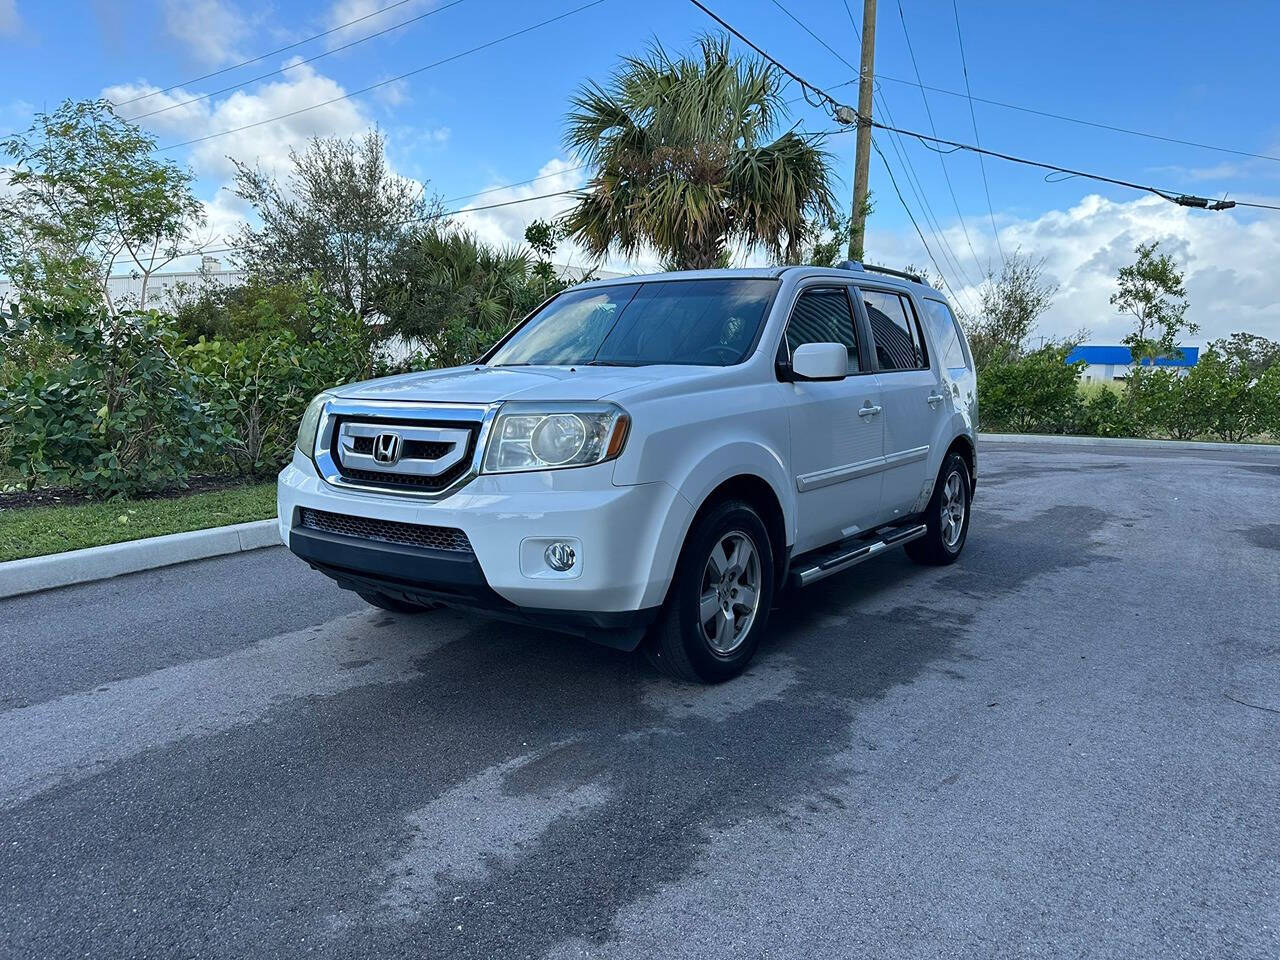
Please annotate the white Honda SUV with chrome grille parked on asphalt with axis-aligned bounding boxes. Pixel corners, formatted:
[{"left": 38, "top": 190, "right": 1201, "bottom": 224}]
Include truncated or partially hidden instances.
[{"left": 279, "top": 262, "right": 977, "bottom": 681}]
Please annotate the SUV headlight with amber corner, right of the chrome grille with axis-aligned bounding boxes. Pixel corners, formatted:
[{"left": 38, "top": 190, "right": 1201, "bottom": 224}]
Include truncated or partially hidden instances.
[{"left": 484, "top": 403, "right": 631, "bottom": 474}]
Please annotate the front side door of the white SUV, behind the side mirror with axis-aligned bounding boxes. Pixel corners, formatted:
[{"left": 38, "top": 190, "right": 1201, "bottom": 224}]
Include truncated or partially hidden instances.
[{"left": 778, "top": 284, "right": 884, "bottom": 553}]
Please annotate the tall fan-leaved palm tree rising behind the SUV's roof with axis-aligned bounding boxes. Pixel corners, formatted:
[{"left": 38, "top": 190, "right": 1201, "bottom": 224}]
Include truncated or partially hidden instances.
[{"left": 564, "top": 36, "right": 835, "bottom": 269}]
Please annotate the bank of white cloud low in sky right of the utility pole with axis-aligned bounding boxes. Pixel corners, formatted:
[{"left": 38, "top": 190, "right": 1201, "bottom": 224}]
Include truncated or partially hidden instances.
[{"left": 868, "top": 195, "right": 1280, "bottom": 343}]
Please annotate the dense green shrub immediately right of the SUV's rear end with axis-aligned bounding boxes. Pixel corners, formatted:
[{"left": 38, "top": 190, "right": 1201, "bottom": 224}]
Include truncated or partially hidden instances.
[{"left": 978, "top": 344, "right": 1082, "bottom": 433}]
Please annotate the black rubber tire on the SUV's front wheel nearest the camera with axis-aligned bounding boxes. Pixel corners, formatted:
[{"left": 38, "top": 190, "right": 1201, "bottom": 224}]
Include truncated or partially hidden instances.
[{"left": 644, "top": 500, "right": 774, "bottom": 684}]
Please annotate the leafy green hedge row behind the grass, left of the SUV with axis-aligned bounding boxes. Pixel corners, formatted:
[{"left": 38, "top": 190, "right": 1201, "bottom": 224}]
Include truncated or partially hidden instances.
[{"left": 0, "top": 294, "right": 389, "bottom": 498}]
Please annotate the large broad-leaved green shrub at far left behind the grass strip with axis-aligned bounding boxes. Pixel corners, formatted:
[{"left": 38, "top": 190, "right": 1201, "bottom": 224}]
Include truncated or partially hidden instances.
[{"left": 0, "top": 305, "right": 218, "bottom": 498}]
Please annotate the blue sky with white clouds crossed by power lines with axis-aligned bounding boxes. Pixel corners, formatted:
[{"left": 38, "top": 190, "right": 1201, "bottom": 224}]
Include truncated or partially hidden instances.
[{"left": 0, "top": 0, "right": 1280, "bottom": 342}]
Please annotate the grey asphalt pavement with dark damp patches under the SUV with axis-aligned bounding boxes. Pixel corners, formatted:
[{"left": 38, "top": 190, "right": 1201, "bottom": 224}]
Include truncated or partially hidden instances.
[{"left": 0, "top": 444, "right": 1280, "bottom": 960}]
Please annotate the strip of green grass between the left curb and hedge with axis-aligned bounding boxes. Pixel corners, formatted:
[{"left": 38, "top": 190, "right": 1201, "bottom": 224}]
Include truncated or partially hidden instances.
[{"left": 0, "top": 484, "right": 275, "bottom": 562}]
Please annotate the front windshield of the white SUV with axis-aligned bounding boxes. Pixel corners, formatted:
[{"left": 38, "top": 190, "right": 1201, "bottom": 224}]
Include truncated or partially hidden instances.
[{"left": 489, "top": 278, "right": 778, "bottom": 366}]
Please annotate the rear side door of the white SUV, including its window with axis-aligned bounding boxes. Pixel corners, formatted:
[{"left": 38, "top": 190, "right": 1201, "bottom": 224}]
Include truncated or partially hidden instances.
[{"left": 859, "top": 285, "right": 947, "bottom": 522}]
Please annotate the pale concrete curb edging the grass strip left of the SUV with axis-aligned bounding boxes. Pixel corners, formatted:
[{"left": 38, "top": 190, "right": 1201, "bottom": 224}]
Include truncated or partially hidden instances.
[{"left": 0, "top": 517, "right": 280, "bottom": 598}]
